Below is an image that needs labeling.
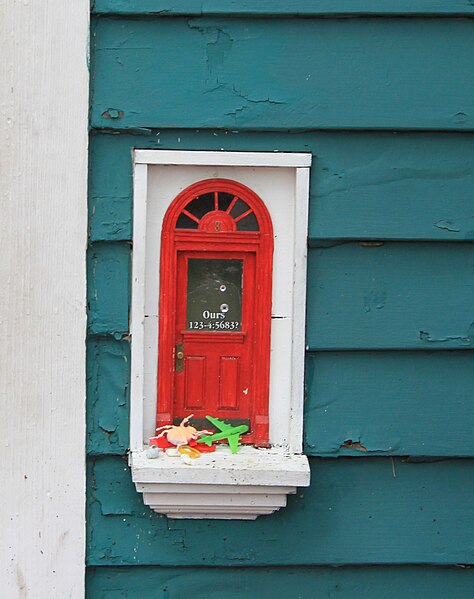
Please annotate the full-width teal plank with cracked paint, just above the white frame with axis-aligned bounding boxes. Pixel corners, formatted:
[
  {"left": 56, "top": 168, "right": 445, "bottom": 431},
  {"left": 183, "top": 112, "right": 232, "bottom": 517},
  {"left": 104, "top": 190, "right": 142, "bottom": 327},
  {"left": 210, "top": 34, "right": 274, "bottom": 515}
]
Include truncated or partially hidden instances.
[{"left": 91, "top": 18, "right": 474, "bottom": 130}]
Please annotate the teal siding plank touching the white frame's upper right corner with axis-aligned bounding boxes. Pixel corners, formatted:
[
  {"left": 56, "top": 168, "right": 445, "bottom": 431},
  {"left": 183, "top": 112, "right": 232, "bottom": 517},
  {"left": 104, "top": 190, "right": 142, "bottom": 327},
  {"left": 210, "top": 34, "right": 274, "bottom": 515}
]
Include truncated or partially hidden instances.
[{"left": 309, "top": 133, "right": 474, "bottom": 244}]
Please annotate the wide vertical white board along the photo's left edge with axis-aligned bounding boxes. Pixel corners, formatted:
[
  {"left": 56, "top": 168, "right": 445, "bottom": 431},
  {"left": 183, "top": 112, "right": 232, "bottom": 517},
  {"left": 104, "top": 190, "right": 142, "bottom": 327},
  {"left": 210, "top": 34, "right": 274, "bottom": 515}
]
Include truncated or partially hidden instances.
[{"left": 0, "top": 0, "right": 89, "bottom": 599}]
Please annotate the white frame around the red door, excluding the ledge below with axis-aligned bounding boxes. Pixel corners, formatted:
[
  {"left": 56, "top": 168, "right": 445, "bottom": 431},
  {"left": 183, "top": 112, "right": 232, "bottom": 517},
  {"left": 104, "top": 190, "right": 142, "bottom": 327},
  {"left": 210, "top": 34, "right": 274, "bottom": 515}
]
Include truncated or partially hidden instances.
[{"left": 130, "top": 150, "right": 311, "bottom": 454}]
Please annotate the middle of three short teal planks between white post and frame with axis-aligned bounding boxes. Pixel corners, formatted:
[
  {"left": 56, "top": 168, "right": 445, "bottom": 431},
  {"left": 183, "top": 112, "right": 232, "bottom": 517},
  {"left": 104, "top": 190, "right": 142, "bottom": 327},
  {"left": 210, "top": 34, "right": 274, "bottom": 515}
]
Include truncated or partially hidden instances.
[{"left": 87, "top": 243, "right": 130, "bottom": 339}]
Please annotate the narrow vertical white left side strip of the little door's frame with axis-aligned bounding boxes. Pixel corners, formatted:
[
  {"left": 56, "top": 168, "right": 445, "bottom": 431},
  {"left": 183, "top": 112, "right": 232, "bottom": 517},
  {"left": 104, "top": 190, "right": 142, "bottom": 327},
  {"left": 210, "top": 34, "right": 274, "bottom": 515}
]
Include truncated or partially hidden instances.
[{"left": 130, "top": 164, "right": 148, "bottom": 451}]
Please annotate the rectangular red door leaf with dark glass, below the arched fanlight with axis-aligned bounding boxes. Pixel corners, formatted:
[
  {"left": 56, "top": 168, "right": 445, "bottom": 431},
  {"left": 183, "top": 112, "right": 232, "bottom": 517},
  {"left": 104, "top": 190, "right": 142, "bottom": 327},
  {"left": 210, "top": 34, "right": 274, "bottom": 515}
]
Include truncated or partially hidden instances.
[{"left": 173, "top": 251, "right": 255, "bottom": 440}]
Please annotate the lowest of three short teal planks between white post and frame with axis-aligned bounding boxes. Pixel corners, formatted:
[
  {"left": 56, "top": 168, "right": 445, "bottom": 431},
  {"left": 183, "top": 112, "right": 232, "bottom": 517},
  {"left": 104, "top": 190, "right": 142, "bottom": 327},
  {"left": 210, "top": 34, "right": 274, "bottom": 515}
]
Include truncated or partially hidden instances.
[{"left": 87, "top": 337, "right": 130, "bottom": 455}]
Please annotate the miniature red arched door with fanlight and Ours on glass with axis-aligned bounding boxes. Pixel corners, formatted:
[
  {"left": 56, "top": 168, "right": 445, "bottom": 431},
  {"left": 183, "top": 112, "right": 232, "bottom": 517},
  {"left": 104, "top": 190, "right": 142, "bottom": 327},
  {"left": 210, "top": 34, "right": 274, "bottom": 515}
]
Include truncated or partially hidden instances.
[{"left": 157, "top": 179, "right": 273, "bottom": 445}]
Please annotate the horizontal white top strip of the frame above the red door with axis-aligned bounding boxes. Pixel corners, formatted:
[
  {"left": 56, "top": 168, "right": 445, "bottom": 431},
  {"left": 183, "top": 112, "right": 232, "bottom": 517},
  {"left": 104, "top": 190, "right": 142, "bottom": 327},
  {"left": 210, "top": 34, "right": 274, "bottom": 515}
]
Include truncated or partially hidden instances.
[{"left": 135, "top": 150, "right": 311, "bottom": 167}]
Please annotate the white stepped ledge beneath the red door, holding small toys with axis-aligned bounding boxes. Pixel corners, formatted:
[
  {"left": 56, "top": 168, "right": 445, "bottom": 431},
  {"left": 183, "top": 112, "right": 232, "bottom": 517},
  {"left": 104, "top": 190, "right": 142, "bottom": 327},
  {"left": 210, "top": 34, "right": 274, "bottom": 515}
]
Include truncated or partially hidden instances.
[{"left": 130, "top": 446, "right": 310, "bottom": 520}]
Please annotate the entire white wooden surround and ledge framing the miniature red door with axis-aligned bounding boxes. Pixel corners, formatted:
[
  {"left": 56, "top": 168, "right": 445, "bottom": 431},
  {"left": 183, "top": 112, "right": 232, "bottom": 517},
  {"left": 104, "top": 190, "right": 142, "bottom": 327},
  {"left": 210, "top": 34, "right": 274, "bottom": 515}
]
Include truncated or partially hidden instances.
[{"left": 130, "top": 150, "right": 311, "bottom": 519}]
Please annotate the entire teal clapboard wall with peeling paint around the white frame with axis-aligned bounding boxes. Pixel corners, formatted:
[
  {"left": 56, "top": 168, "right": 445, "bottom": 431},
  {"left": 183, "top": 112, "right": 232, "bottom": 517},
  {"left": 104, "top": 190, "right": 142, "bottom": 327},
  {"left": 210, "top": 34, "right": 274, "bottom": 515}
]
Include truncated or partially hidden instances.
[{"left": 87, "top": 5, "right": 474, "bottom": 599}]
